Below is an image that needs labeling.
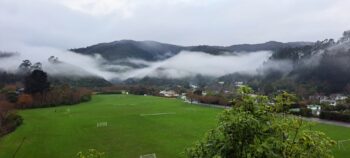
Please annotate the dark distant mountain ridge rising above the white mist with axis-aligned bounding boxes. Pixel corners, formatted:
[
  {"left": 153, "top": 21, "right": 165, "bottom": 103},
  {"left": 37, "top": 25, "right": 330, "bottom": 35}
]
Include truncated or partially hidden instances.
[{"left": 70, "top": 40, "right": 313, "bottom": 61}]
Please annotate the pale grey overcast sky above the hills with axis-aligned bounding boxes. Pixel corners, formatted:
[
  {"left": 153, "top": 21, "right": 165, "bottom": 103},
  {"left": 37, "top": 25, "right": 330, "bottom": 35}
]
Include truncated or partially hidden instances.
[{"left": 0, "top": 0, "right": 350, "bottom": 50}]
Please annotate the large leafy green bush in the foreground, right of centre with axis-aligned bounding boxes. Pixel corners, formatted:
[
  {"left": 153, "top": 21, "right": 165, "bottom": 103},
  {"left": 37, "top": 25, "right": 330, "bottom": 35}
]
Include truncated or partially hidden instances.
[{"left": 186, "top": 87, "right": 335, "bottom": 158}]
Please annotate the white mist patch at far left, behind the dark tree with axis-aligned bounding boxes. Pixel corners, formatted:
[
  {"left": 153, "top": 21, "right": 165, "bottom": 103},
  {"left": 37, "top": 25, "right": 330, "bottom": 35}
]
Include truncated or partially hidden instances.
[{"left": 0, "top": 44, "right": 115, "bottom": 79}]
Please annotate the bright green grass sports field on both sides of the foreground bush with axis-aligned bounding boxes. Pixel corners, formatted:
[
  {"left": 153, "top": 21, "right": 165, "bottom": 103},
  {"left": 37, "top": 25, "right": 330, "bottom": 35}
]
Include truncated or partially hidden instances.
[{"left": 0, "top": 95, "right": 350, "bottom": 158}]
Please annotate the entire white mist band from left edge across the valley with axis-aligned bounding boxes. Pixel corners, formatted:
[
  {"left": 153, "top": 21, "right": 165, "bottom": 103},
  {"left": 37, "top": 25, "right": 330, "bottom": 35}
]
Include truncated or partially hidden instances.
[{"left": 0, "top": 45, "right": 272, "bottom": 80}]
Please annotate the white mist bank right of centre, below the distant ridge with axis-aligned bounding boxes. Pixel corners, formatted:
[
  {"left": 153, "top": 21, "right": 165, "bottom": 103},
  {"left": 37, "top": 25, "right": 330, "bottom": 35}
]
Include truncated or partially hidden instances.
[{"left": 119, "top": 51, "right": 272, "bottom": 79}]
